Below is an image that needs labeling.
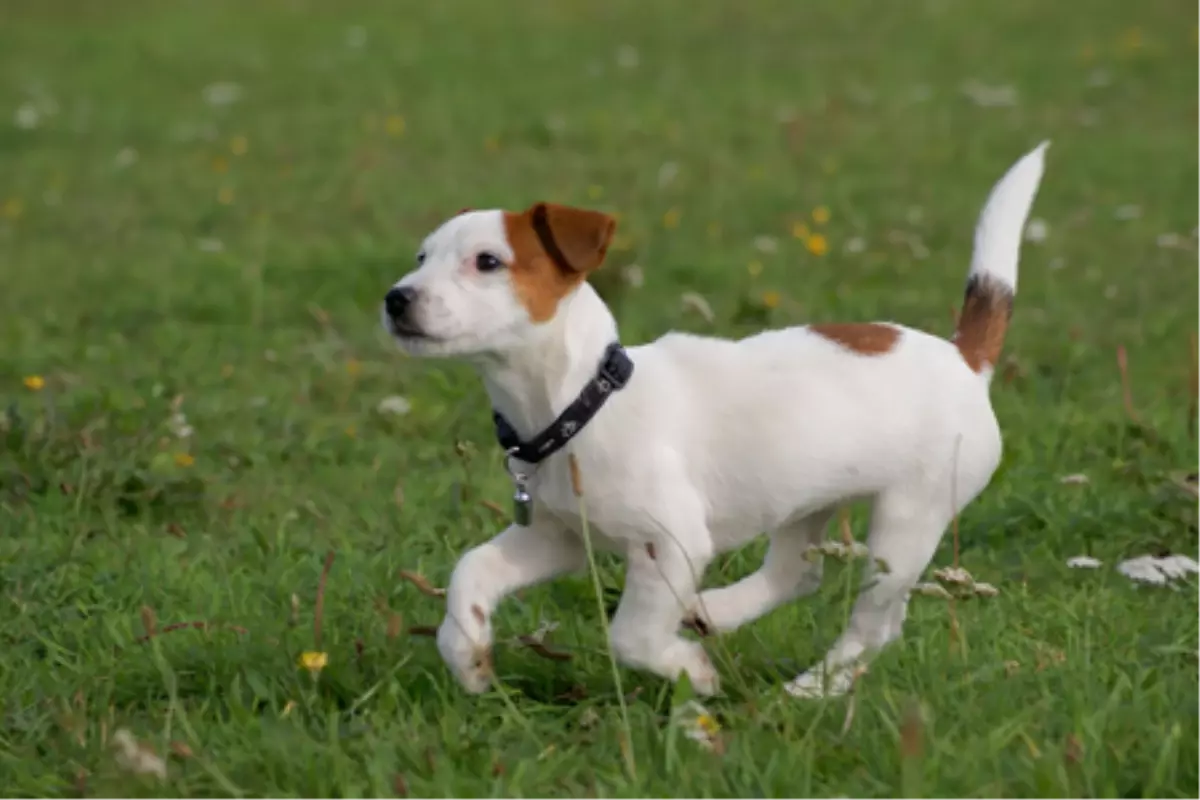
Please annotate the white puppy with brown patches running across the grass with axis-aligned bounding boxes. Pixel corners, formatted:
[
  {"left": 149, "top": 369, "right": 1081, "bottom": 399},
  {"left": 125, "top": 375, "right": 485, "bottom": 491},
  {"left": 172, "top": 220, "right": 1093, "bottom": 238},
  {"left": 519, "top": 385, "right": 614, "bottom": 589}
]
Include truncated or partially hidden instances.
[{"left": 382, "top": 142, "right": 1049, "bottom": 697}]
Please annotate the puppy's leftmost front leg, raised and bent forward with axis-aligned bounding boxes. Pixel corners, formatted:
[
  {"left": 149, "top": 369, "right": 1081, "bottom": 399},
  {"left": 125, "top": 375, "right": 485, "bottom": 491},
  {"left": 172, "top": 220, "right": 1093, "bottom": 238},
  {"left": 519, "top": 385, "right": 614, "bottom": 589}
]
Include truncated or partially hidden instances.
[{"left": 438, "top": 522, "right": 586, "bottom": 693}]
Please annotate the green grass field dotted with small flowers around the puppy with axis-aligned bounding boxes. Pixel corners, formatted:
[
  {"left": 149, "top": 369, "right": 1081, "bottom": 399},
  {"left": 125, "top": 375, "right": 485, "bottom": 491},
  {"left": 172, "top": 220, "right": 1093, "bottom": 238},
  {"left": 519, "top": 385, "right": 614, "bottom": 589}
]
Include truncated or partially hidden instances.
[{"left": 0, "top": 0, "right": 1200, "bottom": 799}]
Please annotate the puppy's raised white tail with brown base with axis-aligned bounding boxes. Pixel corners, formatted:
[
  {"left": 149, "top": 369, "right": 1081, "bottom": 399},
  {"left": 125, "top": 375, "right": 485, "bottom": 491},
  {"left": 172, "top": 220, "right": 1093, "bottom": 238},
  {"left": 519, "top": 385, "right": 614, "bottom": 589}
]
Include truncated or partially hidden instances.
[{"left": 954, "top": 142, "right": 1050, "bottom": 381}]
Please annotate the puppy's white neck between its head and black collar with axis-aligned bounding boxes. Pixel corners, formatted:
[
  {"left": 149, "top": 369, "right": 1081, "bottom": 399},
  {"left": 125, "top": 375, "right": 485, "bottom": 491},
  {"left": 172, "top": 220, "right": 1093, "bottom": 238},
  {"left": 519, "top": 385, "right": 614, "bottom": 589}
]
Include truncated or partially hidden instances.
[{"left": 480, "top": 283, "right": 617, "bottom": 440}]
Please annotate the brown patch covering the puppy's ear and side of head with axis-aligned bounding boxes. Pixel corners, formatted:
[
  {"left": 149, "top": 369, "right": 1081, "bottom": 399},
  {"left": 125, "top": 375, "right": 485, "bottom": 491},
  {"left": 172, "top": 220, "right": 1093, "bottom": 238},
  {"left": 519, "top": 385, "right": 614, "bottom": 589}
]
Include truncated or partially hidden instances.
[{"left": 504, "top": 203, "right": 617, "bottom": 323}]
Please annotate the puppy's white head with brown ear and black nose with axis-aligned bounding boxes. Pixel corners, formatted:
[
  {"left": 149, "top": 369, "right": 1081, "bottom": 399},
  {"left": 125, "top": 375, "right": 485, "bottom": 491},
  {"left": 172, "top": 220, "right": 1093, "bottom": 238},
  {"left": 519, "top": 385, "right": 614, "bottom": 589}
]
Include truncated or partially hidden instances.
[{"left": 383, "top": 203, "right": 617, "bottom": 356}]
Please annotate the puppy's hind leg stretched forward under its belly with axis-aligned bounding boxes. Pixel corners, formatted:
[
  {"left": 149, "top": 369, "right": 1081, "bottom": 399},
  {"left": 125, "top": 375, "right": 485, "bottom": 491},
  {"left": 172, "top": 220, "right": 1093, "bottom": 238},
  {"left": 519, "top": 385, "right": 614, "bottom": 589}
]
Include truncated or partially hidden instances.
[{"left": 684, "top": 510, "right": 833, "bottom": 633}]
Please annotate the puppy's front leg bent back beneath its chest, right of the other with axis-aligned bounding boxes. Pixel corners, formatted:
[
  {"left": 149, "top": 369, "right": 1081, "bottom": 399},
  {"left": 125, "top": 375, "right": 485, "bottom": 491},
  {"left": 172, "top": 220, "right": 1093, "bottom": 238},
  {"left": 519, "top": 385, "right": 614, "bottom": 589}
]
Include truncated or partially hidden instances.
[{"left": 610, "top": 539, "right": 719, "bottom": 694}]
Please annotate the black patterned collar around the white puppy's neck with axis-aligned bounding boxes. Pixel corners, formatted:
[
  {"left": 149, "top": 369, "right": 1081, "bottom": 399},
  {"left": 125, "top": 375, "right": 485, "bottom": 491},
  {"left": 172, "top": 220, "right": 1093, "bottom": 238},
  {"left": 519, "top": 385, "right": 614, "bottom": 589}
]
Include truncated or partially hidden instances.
[{"left": 492, "top": 342, "right": 634, "bottom": 464}]
